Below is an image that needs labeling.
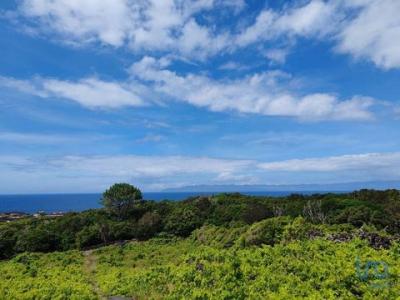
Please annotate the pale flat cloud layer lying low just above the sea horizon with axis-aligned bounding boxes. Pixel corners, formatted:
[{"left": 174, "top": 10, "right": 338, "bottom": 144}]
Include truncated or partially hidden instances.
[{"left": 0, "top": 152, "right": 400, "bottom": 193}]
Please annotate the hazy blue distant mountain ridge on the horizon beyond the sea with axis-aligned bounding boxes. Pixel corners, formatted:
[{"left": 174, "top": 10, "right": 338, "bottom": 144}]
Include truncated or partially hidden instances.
[{"left": 162, "top": 181, "right": 400, "bottom": 192}]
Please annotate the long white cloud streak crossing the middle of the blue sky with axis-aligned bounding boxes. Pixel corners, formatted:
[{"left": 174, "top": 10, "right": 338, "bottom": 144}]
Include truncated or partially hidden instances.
[{"left": 0, "top": 63, "right": 376, "bottom": 121}]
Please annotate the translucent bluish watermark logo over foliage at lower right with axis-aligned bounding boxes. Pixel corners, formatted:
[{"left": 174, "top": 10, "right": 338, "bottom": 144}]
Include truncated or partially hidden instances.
[{"left": 355, "top": 256, "right": 389, "bottom": 288}]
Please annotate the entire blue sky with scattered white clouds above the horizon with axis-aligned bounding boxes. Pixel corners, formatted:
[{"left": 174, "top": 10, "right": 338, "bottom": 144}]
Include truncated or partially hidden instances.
[{"left": 0, "top": 0, "right": 400, "bottom": 194}]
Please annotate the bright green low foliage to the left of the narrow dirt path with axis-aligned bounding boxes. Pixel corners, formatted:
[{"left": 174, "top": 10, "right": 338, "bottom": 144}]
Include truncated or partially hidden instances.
[{"left": 0, "top": 251, "right": 97, "bottom": 300}]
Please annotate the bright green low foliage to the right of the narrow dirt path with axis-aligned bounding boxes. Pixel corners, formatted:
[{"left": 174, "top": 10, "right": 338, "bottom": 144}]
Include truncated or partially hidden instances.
[{"left": 90, "top": 228, "right": 400, "bottom": 299}]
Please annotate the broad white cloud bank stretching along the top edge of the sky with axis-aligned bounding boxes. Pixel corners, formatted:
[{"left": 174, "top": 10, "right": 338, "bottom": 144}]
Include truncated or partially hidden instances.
[{"left": 11, "top": 0, "right": 400, "bottom": 69}]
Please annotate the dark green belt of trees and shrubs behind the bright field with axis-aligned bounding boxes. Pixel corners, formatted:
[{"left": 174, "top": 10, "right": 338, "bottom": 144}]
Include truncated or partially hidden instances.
[{"left": 0, "top": 189, "right": 400, "bottom": 259}]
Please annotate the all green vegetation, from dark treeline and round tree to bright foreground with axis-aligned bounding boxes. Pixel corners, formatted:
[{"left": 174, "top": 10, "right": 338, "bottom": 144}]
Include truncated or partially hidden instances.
[{"left": 0, "top": 185, "right": 400, "bottom": 299}]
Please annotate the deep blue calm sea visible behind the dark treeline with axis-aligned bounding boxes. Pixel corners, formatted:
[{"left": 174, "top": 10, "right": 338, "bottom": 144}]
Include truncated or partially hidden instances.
[{"left": 0, "top": 192, "right": 318, "bottom": 213}]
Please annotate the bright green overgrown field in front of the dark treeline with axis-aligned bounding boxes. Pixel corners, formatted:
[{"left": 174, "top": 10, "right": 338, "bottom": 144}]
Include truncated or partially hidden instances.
[{"left": 0, "top": 217, "right": 400, "bottom": 299}]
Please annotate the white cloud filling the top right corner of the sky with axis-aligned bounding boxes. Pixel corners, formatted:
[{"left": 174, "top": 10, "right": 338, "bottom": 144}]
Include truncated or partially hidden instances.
[{"left": 236, "top": 0, "right": 400, "bottom": 69}]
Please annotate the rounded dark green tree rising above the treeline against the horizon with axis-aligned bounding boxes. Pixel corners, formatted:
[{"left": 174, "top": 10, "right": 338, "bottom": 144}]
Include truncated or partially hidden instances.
[{"left": 102, "top": 183, "right": 142, "bottom": 219}]
